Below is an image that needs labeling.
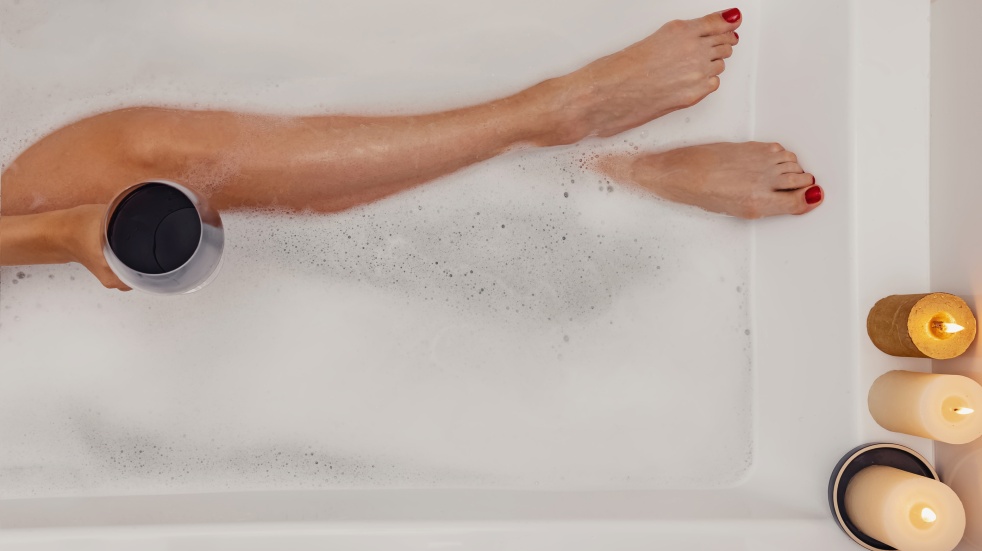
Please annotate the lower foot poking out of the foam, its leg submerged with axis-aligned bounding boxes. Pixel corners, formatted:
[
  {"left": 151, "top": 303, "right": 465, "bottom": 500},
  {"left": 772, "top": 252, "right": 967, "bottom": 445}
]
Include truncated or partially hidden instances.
[{"left": 596, "top": 142, "right": 825, "bottom": 218}]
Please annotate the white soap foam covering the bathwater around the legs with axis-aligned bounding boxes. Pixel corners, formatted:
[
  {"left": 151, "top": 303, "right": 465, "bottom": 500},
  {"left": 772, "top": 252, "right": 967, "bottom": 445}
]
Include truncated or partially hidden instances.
[{"left": 0, "top": 0, "right": 752, "bottom": 497}]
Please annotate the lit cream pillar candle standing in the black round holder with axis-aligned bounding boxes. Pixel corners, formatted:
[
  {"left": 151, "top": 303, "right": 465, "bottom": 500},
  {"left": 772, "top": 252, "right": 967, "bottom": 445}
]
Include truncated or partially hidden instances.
[{"left": 845, "top": 465, "right": 965, "bottom": 551}]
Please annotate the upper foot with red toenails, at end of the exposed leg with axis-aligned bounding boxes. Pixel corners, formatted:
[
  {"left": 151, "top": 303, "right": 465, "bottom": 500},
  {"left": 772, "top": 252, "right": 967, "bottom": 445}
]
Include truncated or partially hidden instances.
[{"left": 543, "top": 8, "right": 742, "bottom": 143}]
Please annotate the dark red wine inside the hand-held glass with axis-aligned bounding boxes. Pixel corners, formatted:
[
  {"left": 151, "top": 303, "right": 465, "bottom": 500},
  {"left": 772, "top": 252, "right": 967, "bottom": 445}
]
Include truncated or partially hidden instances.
[{"left": 106, "top": 183, "right": 201, "bottom": 274}]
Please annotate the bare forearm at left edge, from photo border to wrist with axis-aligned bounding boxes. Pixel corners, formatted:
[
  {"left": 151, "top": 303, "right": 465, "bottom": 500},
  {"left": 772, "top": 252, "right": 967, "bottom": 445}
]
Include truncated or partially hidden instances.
[{"left": 0, "top": 211, "right": 74, "bottom": 266}]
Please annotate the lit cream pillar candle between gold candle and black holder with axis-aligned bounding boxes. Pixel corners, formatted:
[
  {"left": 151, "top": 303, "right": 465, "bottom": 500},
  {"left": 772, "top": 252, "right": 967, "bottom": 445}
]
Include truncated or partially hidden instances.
[{"left": 869, "top": 371, "right": 982, "bottom": 444}]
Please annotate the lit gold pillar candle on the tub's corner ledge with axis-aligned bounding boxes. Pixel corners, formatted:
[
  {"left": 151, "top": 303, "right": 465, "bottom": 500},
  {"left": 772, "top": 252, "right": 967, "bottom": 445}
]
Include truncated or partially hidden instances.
[{"left": 866, "top": 293, "right": 976, "bottom": 360}]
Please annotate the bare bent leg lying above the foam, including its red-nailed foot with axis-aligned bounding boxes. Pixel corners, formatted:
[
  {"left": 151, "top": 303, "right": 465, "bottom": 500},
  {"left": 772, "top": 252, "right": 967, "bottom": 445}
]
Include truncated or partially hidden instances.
[{"left": 2, "top": 10, "right": 740, "bottom": 214}]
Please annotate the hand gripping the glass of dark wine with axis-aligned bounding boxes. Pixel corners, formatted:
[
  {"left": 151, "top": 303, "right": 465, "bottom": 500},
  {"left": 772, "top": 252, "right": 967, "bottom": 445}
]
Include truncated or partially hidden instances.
[{"left": 54, "top": 205, "right": 130, "bottom": 291}]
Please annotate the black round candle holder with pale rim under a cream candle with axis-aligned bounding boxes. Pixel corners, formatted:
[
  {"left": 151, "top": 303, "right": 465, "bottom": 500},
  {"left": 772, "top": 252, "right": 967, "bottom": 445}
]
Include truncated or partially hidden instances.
[{"left": 829, "top": 444, "right": 940, "bottom": 551}]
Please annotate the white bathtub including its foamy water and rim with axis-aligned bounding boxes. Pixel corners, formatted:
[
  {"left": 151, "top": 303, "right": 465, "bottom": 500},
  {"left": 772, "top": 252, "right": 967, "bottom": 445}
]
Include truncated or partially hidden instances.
[{"left": 0, "top": 0, "right": 932, "bottom": 550}]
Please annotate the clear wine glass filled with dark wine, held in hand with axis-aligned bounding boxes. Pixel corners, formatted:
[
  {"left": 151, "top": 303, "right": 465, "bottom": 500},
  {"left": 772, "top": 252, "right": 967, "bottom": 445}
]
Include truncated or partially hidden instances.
[{"left": 102, "top": 180, "right": 225, "bottom": 295}]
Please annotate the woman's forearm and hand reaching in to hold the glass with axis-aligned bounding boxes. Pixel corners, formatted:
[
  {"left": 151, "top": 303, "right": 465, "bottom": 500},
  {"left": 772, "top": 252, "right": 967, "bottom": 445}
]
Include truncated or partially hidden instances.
[{"left": 0, "top": 205, "right": 129, "bottom": 291}]
